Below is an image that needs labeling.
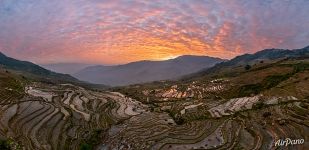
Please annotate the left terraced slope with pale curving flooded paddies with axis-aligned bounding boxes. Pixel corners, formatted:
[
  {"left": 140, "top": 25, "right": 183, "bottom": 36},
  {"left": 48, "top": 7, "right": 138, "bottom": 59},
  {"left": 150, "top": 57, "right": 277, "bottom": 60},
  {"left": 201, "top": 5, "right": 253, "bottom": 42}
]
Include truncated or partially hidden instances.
[{"left": 0, "top": 72, "right": 147, "bottom": 149}]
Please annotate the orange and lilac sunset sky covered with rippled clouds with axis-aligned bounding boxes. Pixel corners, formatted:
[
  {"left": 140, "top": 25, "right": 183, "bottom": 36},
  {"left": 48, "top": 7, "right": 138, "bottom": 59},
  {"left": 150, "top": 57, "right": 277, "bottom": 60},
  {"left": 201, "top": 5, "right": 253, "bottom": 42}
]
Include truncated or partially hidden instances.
[{"left": 0, "top": 0, "right": 309, "bottom": 64}]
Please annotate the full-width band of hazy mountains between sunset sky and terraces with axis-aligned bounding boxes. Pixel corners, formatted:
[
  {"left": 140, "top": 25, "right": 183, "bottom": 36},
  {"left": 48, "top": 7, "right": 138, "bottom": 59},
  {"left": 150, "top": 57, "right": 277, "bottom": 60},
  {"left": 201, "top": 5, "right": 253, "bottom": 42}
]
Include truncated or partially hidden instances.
[{"left": 0, "top": 46, "right": 309, "bottom": 86}]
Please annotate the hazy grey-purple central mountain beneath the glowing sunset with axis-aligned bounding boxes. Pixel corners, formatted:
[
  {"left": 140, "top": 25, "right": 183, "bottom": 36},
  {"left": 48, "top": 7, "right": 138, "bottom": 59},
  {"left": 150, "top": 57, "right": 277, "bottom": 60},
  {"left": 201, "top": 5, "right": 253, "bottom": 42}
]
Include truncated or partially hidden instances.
[{"left": 73, "top": 55, "right": 224, "bottom": 86}]
